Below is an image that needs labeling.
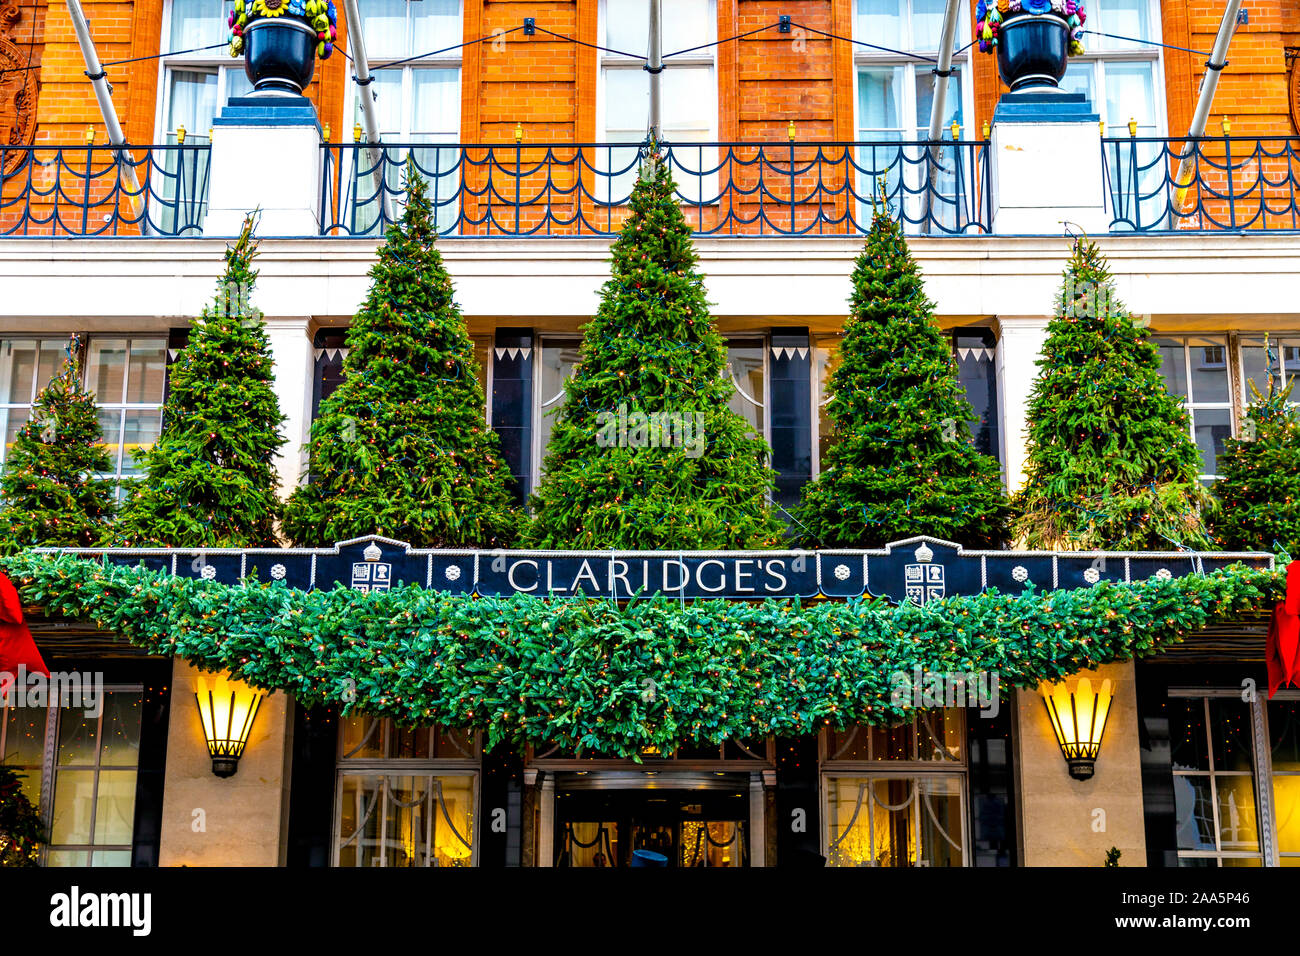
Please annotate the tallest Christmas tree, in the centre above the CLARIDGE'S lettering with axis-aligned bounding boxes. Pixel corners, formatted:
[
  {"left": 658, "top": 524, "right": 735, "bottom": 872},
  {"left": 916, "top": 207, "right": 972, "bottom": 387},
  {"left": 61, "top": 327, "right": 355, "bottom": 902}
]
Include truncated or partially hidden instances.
[{"left": 528, "top": 140, "right": 781, "bottom": 549}]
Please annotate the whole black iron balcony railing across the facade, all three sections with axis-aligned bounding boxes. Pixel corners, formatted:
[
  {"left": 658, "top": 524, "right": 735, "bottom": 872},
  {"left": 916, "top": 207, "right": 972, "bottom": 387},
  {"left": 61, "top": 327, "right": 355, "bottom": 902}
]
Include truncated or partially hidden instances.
[{"left": 0, "top": 137, "right": 1300, "bottom": 238}]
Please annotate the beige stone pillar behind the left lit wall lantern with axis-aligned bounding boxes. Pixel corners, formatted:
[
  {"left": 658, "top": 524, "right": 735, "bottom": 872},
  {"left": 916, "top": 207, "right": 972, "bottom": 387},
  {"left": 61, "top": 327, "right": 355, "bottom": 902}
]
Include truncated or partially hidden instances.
[{"left": 159, "top": 658, "right": 294, "bottom": 866}]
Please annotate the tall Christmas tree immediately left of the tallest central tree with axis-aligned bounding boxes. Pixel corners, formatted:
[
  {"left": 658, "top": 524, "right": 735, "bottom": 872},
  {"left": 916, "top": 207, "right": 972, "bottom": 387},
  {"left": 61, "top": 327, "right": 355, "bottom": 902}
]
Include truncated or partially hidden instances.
[{"left": 283, "top": 165, "right": 520, "bottom": 548}]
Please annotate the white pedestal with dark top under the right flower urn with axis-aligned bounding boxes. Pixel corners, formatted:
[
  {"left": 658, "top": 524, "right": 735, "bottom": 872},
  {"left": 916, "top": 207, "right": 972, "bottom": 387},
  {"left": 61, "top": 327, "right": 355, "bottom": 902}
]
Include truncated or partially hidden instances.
[{"left": 989, "top": 92, "right": 1110, "bottom": 235}]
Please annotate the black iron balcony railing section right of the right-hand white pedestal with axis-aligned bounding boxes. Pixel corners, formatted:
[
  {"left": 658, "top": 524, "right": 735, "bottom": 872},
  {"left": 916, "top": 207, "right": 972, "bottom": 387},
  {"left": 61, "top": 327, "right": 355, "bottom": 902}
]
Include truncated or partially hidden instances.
[{"left": 1101, "top": 137, "right": 1300, "bottom": 233}]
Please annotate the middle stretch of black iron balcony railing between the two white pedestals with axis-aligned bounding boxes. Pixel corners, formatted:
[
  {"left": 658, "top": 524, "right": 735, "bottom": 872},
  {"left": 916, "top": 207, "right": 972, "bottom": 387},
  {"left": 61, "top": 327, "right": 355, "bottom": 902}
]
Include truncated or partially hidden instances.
[{"left": 321, "top": 140, "right": 991, "bottom": 237}]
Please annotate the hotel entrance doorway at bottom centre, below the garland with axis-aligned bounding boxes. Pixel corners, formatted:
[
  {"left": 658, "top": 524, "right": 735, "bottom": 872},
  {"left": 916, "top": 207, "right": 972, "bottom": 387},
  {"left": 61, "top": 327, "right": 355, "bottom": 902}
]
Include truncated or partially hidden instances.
[{"left": 553, "top": 771, "right": 762, "bottom": 868}]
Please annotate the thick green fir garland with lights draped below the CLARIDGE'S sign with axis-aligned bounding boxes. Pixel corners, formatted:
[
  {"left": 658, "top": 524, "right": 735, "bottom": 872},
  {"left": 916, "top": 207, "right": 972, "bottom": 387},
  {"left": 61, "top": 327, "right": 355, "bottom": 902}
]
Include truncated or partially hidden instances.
[{"left": 0, "top": 553, "right": 1282, "bottom": 756}]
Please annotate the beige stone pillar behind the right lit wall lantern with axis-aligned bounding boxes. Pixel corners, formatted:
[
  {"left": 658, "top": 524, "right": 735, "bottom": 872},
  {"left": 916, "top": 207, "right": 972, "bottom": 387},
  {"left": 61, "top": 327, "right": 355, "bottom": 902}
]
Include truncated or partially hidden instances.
[{"left": 1015, "top": 661, "right": 1147, "bottom": 866}]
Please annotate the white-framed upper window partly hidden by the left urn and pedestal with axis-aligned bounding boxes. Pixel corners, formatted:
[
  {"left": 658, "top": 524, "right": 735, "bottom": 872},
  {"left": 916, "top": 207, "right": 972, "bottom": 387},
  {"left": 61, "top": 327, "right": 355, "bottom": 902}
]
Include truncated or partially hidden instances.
[{"left": 152, "top": 0, "right": 252, "bottom": 232}]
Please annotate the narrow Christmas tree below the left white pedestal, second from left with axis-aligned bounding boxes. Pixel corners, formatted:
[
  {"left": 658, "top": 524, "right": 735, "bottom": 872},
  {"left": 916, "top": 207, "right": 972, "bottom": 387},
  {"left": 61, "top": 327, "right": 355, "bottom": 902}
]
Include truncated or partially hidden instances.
[{"left": 118, "top": 217, "right": 285, "bottom": 548}]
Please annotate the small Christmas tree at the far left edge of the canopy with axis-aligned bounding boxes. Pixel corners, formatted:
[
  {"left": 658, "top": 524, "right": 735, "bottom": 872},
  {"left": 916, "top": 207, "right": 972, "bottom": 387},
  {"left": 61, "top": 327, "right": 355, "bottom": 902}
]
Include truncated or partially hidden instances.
[{"left": 0, "top": 338, "right": 113, "bottom": 551}]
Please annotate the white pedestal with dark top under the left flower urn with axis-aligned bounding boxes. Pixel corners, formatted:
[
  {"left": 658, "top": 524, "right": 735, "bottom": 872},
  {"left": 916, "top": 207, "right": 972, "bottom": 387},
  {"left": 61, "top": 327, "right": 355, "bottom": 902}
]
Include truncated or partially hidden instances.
[{"left": 203, "top": 96, "right": 322, "bottom": 235}]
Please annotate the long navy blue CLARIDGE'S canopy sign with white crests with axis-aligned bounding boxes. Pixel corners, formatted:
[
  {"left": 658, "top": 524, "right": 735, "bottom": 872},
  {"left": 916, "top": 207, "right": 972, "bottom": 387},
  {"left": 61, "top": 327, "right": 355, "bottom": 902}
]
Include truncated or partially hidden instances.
[{"left": 42, "top": 537, "right": 1273, "bottom": 605}]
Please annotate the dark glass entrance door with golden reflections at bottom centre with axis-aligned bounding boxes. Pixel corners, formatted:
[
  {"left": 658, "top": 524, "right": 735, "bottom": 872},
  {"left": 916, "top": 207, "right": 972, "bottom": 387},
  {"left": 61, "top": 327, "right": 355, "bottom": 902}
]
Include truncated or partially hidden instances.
[{"left": 555, "top": 790, "right": 749, "bottom": 868}]
